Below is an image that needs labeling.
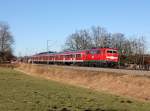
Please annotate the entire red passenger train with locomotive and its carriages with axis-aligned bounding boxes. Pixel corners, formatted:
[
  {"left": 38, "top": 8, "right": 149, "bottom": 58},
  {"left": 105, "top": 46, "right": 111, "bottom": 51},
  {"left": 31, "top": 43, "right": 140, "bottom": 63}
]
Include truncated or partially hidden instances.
[{"left": 31, "top": 48, "right": 119, "bottom": 66}]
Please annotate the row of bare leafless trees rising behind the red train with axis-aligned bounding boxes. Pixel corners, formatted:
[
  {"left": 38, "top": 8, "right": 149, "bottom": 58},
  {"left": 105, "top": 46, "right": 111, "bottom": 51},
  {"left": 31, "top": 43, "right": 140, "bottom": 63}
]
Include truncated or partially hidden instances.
[{"left": 64, "top": 26, "right": 146, "bottom": 63}]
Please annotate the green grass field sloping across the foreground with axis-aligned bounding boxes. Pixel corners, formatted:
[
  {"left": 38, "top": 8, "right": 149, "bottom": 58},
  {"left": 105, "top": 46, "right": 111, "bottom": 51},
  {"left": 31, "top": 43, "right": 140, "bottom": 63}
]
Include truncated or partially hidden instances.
[{"left": 0, "top": 68, "right": 150, "bottom": 111}]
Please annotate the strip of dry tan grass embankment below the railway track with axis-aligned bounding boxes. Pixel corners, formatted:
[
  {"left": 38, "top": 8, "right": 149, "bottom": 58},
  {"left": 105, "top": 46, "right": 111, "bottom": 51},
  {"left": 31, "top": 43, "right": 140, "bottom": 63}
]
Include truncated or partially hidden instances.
[{"left": 18, "top": 64, "right": 150, "bottom": 101}]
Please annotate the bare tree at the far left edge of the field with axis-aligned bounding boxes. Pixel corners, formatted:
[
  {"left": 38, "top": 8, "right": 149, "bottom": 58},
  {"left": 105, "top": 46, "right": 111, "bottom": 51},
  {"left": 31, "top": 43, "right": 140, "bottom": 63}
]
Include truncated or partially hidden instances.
[{"left": 0, "top": 22, "right": 14, "bottom": 63}]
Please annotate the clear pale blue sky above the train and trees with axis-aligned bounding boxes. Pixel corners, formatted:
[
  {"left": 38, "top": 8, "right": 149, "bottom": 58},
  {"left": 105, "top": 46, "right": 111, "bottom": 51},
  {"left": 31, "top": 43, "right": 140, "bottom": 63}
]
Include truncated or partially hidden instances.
[{"left": 0, "top": 0, "right": 150, "bottom": 56}]
